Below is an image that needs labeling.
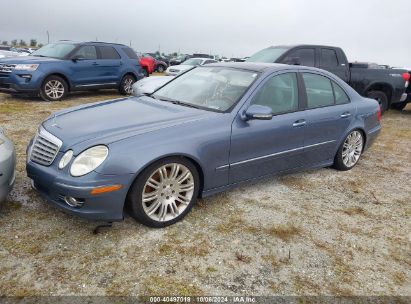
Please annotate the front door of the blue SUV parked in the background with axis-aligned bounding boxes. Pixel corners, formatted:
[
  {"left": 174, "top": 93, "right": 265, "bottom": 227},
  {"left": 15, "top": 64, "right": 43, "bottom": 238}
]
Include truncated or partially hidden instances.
[{"left": 70, "top": 45, "right": 100, "bottom": 88}]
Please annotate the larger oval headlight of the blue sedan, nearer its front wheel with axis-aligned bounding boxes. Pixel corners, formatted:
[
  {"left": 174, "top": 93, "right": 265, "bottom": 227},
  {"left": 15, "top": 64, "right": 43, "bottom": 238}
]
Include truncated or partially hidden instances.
[{"left": 70, "top": 146, "right": 108, "bottom": 176}]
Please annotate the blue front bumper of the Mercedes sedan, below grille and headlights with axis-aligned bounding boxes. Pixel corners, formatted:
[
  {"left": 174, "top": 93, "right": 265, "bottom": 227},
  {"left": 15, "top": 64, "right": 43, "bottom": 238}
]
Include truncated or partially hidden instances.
[{"left": 26, "top": 159, "right": 133, "bottom": 221}]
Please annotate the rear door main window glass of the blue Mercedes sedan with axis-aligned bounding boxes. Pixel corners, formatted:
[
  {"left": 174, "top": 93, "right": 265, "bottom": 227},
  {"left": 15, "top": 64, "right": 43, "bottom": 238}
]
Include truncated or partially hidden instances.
[{"left": 303, "top": 73, "right": 334, "bottom": 109}]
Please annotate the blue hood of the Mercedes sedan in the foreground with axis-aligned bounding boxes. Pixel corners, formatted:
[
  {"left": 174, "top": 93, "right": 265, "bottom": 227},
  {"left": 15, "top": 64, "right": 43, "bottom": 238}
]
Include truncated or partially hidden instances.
[{"left": 43, "top": 97, "right": 216, "bottom": 152}]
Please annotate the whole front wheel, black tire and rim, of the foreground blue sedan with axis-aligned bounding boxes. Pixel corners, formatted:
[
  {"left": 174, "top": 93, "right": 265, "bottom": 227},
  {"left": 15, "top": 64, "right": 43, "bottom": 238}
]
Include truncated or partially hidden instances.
[{"left": 127, "top": 157, "right": 200, "bottom": 228}]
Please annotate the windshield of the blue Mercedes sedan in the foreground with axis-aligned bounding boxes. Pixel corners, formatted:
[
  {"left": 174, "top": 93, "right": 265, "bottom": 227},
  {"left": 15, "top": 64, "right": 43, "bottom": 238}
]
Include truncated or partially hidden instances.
[{"left": 152, "top": 67, "right": 258, "bottom": 112}]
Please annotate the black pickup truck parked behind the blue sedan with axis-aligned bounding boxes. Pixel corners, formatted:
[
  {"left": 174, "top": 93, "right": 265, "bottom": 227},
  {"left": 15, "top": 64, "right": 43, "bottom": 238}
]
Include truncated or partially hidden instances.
[{"left": 247, "top": 45, "right": 409, "bottom": 112}]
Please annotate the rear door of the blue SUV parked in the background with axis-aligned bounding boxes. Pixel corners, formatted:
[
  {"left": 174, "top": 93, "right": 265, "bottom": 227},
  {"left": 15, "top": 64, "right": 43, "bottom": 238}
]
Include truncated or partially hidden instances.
[{"left": 97, "top": 46, "right": 123, "bottom": 85}]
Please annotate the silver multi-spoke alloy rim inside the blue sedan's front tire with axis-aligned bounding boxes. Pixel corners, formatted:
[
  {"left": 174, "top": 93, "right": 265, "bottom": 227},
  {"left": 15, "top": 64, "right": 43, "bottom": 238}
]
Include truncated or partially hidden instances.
[{"left": 142, "top": 163, "right": 194, "bottom": 222}]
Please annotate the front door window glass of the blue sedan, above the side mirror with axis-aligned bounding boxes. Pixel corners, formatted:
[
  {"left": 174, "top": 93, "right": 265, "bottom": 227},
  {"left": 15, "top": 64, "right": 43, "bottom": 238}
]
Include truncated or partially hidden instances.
[{"left": 251, "top": 73, "right": 298, "bottom": 115}]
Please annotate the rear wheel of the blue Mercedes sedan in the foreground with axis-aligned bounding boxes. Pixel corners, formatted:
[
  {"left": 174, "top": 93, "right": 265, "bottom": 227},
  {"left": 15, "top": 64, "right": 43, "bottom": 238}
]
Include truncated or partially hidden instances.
[{"left": 334, "top": 130, "right": 364, "bottom": 171}]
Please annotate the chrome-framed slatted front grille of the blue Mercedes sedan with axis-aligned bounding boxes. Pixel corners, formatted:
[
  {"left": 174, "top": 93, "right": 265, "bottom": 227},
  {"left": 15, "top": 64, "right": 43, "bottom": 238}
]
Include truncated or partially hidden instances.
[{"left": 30, "top": 127, "right": 63, "bottom": 166}]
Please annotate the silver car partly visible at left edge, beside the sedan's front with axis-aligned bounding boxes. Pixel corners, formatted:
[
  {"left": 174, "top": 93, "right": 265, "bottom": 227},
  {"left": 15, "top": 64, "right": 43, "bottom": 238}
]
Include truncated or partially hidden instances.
[{"left": 0, "top": 127, "right": 16, "bottom": 203}]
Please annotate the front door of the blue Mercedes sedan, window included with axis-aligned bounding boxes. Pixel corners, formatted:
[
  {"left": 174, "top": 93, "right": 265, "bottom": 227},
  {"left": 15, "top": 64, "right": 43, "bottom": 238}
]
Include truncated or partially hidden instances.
[{"left": 230, "top": 72, "right": 305, "bottom": 183}]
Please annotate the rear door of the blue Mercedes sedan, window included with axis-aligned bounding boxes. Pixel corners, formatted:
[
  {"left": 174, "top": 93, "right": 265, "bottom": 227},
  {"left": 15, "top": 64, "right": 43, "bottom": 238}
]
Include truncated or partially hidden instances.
[{"left": 301, "top": 72, "right": 355, "bottom": 166}]
